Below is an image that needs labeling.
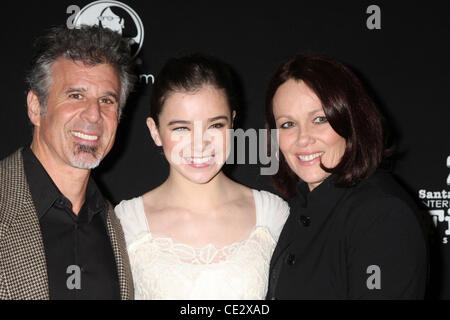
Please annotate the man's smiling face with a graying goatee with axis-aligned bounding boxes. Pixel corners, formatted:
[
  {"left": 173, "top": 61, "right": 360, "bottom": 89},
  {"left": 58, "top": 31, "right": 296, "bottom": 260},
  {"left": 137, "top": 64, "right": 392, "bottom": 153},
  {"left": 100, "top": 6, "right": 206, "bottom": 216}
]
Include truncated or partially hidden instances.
[{"left": 28, "top": 58, "right": 120, "bottom": 169}]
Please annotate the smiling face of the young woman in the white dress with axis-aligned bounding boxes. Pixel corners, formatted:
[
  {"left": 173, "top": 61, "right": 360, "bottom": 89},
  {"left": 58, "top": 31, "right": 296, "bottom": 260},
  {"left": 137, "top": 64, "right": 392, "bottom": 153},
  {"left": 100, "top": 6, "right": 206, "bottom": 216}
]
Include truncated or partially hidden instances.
[{"left": 147, "top": 85, "right": 235, "bottom": 183}]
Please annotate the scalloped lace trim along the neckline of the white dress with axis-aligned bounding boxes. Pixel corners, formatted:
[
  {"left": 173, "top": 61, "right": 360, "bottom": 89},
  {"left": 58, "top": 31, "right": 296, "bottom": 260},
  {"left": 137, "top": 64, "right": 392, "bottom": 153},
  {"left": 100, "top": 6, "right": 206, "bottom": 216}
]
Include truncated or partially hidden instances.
[{"left": 128, "top": 226, "right": 275, "bottom": 265}]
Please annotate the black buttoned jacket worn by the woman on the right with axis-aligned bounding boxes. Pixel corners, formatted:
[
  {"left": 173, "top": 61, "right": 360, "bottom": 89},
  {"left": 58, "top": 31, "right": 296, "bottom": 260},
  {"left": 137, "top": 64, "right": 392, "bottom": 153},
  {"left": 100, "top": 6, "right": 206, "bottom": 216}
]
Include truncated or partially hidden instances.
[{"left": 267, "top": 171, "right": 428, "bottom": 299}]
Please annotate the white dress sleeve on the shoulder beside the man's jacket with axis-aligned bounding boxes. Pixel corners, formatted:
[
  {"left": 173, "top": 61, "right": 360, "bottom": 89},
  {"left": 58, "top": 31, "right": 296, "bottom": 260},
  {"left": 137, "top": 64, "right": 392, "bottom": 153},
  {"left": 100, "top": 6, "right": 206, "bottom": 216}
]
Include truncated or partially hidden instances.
[{"left": 114, "top": 197, "right": 148, "bottom": 247}]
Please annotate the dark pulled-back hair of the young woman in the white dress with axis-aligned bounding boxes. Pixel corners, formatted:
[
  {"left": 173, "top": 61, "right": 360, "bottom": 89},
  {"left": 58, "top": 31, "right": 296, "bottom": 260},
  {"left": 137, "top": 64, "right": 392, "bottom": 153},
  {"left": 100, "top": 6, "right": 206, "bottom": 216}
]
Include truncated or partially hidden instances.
[{"left": 150, "top": 54, "right": 239, "bottom": 125}]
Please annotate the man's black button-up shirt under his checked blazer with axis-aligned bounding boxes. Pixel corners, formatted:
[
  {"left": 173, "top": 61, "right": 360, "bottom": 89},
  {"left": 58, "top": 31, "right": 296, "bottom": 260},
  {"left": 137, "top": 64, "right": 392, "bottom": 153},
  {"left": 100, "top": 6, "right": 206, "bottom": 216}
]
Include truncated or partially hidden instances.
[{"left": 23, "top": 148, "right": 120, "bottom": 299}]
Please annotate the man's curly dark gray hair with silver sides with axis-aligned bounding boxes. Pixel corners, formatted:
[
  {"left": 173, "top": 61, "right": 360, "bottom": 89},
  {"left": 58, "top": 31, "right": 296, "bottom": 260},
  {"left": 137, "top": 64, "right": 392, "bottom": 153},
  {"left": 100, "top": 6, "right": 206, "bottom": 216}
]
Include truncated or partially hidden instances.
[{"left": 27, "top": 26, "right": 136, "bottom": 119}]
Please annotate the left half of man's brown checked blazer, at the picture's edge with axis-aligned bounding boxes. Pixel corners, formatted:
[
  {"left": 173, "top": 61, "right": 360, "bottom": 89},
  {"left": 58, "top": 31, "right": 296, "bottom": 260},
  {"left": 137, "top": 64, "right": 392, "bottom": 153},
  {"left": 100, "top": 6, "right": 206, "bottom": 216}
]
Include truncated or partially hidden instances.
[{"left": 0, "top": 150, "right": 49, "bottom": 300}]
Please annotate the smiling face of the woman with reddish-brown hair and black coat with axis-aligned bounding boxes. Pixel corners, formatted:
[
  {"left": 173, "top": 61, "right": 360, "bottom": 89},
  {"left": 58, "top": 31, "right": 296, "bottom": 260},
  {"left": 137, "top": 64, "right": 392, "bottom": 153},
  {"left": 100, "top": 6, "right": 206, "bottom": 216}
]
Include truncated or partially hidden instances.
[{"left": 273, "top": 79, "right": 345, "bottom": 190}]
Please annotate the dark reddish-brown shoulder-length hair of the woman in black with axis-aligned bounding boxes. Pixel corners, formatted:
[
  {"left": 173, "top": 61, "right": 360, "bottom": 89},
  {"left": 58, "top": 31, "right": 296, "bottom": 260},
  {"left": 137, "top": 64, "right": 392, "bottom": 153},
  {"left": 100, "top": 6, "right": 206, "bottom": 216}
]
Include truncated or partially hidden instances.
[{"left": 266, "top": 55, "right": 390, "bottom": 197}]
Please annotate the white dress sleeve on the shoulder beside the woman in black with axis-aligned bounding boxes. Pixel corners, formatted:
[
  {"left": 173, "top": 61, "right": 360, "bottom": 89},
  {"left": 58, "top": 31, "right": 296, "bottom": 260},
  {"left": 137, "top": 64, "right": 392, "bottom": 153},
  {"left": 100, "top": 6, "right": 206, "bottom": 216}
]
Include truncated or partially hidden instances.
[{"left": 254, "top": 191, "right": 289, "bottom": 242}]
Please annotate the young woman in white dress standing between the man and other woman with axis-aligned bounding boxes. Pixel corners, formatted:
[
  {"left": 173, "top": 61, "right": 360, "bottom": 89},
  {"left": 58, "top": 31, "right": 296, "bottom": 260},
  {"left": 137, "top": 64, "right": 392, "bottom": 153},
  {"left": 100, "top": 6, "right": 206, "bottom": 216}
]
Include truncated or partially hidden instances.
[{"left": 115, "top": 55, "right": 289, "bottom": 299}]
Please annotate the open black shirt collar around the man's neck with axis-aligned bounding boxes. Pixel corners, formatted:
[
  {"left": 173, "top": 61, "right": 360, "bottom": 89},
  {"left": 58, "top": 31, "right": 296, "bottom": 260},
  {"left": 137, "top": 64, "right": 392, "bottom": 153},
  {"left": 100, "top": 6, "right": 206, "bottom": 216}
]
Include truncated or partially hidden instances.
[{"left": 22, "top": 148, "right": 106, "bottom": 221}]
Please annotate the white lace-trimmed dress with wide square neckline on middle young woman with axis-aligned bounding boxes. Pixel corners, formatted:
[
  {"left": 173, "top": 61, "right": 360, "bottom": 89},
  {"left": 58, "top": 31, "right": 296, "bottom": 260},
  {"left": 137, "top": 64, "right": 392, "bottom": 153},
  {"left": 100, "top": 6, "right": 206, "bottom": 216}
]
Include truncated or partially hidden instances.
[{"left": 115, "top": 190, "right": 289, "bottom": 300}]
